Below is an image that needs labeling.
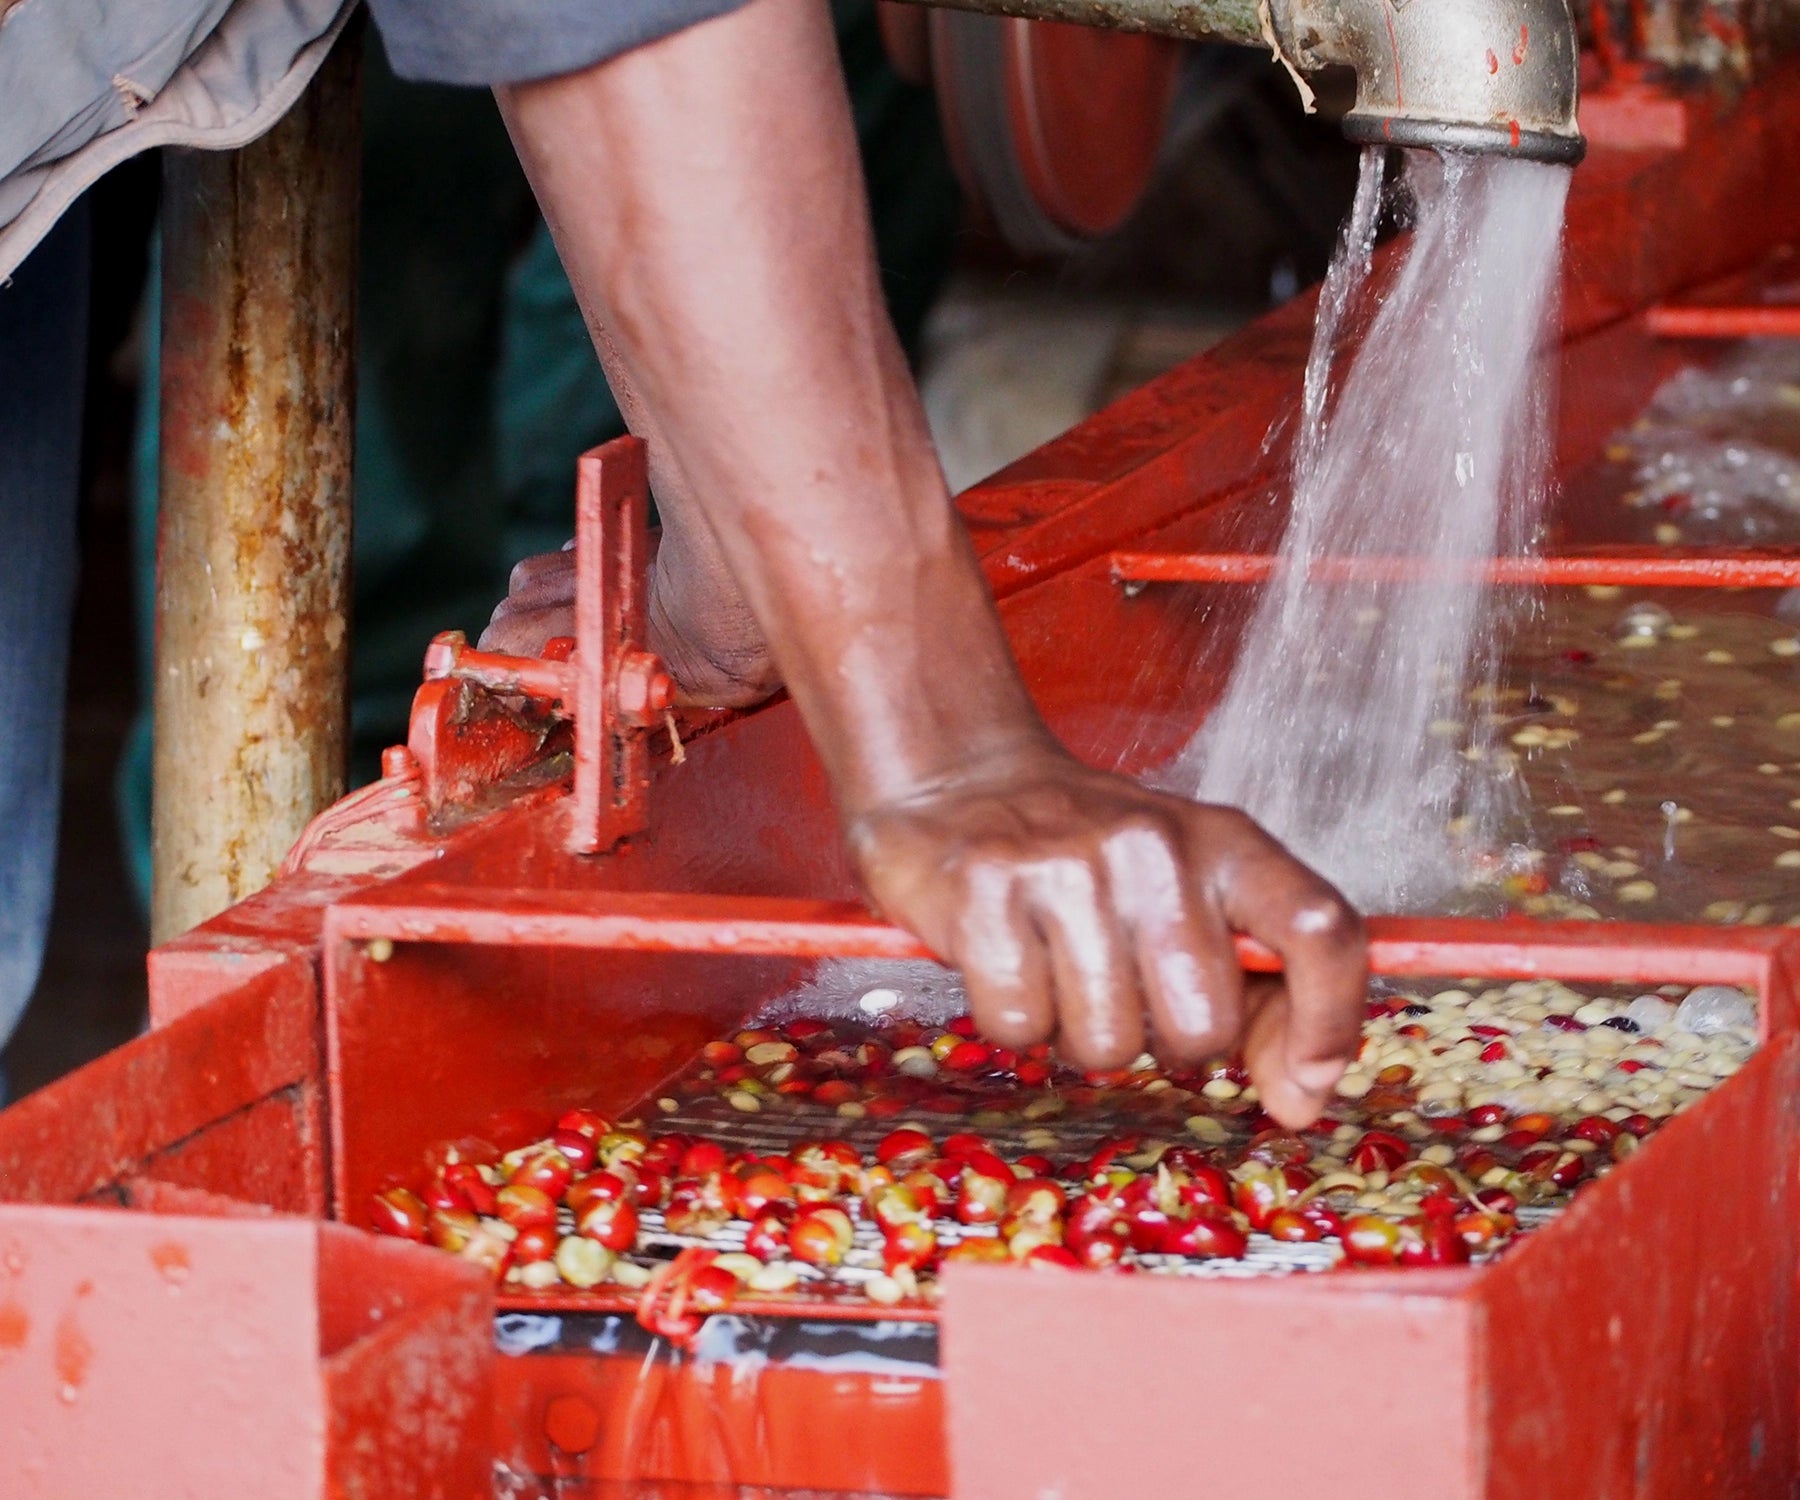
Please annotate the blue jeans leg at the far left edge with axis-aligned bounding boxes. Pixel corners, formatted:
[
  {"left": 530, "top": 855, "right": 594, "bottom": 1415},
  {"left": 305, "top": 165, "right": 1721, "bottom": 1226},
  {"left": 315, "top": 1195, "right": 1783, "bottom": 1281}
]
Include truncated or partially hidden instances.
[{"left": 0, "top": 198, "right": 88, "bottom": 1102}]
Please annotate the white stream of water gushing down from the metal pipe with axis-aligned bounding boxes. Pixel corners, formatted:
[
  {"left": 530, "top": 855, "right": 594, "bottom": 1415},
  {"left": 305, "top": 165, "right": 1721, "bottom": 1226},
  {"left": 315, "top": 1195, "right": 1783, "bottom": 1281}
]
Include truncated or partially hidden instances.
[{"left": 1159, "top": 151, "right": 1570, "bottom": 911}]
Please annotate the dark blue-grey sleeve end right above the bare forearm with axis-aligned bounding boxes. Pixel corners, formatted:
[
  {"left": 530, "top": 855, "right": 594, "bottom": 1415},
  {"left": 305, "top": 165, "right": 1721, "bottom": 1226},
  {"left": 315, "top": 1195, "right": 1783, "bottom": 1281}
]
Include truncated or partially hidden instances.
[{"left": 369, "top": 0, "right": 747, "bottom": 85}]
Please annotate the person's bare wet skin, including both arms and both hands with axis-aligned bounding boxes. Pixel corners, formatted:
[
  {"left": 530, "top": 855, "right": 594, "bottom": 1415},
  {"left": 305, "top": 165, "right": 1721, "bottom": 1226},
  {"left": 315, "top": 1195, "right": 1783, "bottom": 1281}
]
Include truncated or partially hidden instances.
[{"left": 482, "top": 0, "right": 1366, "bottom": 1125}]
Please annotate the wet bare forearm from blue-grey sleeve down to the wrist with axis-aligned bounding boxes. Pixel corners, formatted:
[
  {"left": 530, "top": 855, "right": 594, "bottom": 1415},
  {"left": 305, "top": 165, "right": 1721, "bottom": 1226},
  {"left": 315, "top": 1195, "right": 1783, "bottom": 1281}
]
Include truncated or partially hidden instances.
[{"left": 500, "top": 0, "right": 1042, "bottom": 816}]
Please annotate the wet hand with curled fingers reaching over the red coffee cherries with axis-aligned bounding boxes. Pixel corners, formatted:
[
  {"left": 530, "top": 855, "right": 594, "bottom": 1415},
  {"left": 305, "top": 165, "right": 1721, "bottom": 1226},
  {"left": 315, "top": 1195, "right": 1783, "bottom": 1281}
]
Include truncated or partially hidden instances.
[{"left": 850, "top": 745, "right": 1368, "bottom": 1129}]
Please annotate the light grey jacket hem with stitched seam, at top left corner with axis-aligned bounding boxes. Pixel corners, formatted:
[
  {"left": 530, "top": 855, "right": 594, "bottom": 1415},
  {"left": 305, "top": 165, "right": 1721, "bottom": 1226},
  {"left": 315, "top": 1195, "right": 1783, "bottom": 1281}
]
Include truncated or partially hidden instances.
[{"left": 0, "top": 0, "right": 356, "bottom": 279}]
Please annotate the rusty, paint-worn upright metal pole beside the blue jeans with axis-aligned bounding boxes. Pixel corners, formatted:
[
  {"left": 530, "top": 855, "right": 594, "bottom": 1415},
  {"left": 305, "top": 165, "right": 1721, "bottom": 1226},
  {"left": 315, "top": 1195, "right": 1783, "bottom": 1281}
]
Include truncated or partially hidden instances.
[{"left": 151, "top": 25, "right": 362, "bottom": 942}]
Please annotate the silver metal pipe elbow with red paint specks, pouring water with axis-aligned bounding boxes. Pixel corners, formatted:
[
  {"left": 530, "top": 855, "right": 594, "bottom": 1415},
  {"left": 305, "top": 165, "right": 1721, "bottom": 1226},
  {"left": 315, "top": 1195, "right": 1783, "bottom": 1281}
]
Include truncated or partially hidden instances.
[{"left": 1269, "top": 0, "right": 1588, "bottom": 164}]
